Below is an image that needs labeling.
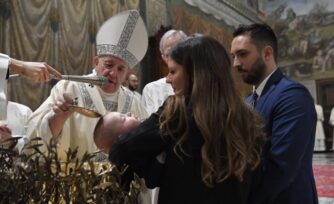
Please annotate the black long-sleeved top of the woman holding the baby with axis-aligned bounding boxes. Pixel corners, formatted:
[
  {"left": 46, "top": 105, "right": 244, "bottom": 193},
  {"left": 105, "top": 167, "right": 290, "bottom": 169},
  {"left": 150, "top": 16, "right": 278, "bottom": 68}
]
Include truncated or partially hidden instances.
[{"left": 109, "top": 107, "right": 261, "bottom": 204}]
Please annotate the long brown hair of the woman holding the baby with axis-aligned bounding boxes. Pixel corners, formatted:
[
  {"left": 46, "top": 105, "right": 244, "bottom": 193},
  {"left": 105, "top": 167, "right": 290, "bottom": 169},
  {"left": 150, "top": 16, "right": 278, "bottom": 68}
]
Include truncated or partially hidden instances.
[{"left": 160, "top": 36, "right": 264, "bottom": 186}]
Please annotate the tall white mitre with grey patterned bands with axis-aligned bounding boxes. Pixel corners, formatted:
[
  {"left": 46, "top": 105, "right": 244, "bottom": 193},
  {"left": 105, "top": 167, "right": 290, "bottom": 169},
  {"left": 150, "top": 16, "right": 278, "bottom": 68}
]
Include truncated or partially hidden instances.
[{"left": 96, "top": 10, "right": 148, "bottom": 68}]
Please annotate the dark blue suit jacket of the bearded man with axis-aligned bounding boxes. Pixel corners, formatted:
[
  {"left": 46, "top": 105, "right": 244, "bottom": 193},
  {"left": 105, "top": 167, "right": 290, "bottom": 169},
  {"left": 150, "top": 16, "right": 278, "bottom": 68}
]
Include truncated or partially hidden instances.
[{"left": 247, "top": 69, "right": 318, "bottom": 204}]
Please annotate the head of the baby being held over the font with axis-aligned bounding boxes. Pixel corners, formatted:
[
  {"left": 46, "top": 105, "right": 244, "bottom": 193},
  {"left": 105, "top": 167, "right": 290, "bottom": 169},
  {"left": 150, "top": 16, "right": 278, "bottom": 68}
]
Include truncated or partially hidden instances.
[{"left": 94, "top": 112, "right": 140, "bottom": 153}]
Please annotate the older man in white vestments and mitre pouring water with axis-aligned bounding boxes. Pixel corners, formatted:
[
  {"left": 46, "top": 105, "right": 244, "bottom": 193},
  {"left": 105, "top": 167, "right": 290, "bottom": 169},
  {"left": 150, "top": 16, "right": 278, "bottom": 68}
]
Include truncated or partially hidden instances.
[{"left": 27, "top": 10, "right": 148, "bottom": 161}]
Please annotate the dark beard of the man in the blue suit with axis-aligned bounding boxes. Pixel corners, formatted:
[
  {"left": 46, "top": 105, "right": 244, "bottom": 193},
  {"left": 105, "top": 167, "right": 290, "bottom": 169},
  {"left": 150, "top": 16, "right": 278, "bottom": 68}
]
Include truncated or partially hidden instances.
[{"left": 241, "top": 57, "right": 266, "bottom": 85}]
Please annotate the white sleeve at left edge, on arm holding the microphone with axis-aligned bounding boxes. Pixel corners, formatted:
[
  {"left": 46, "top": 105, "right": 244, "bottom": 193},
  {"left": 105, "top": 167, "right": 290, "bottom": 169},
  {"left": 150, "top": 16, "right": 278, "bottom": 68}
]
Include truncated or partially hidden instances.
[{"left": 0, "top": 53, "right": 10, "bottom": 120}]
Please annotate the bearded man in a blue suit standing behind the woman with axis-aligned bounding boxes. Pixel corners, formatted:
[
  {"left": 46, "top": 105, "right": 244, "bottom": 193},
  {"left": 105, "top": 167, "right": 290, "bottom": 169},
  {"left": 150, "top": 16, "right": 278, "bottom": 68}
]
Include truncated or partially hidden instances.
[{"left": 231, "top": 24, "right": 318, "bottom": 204}]
